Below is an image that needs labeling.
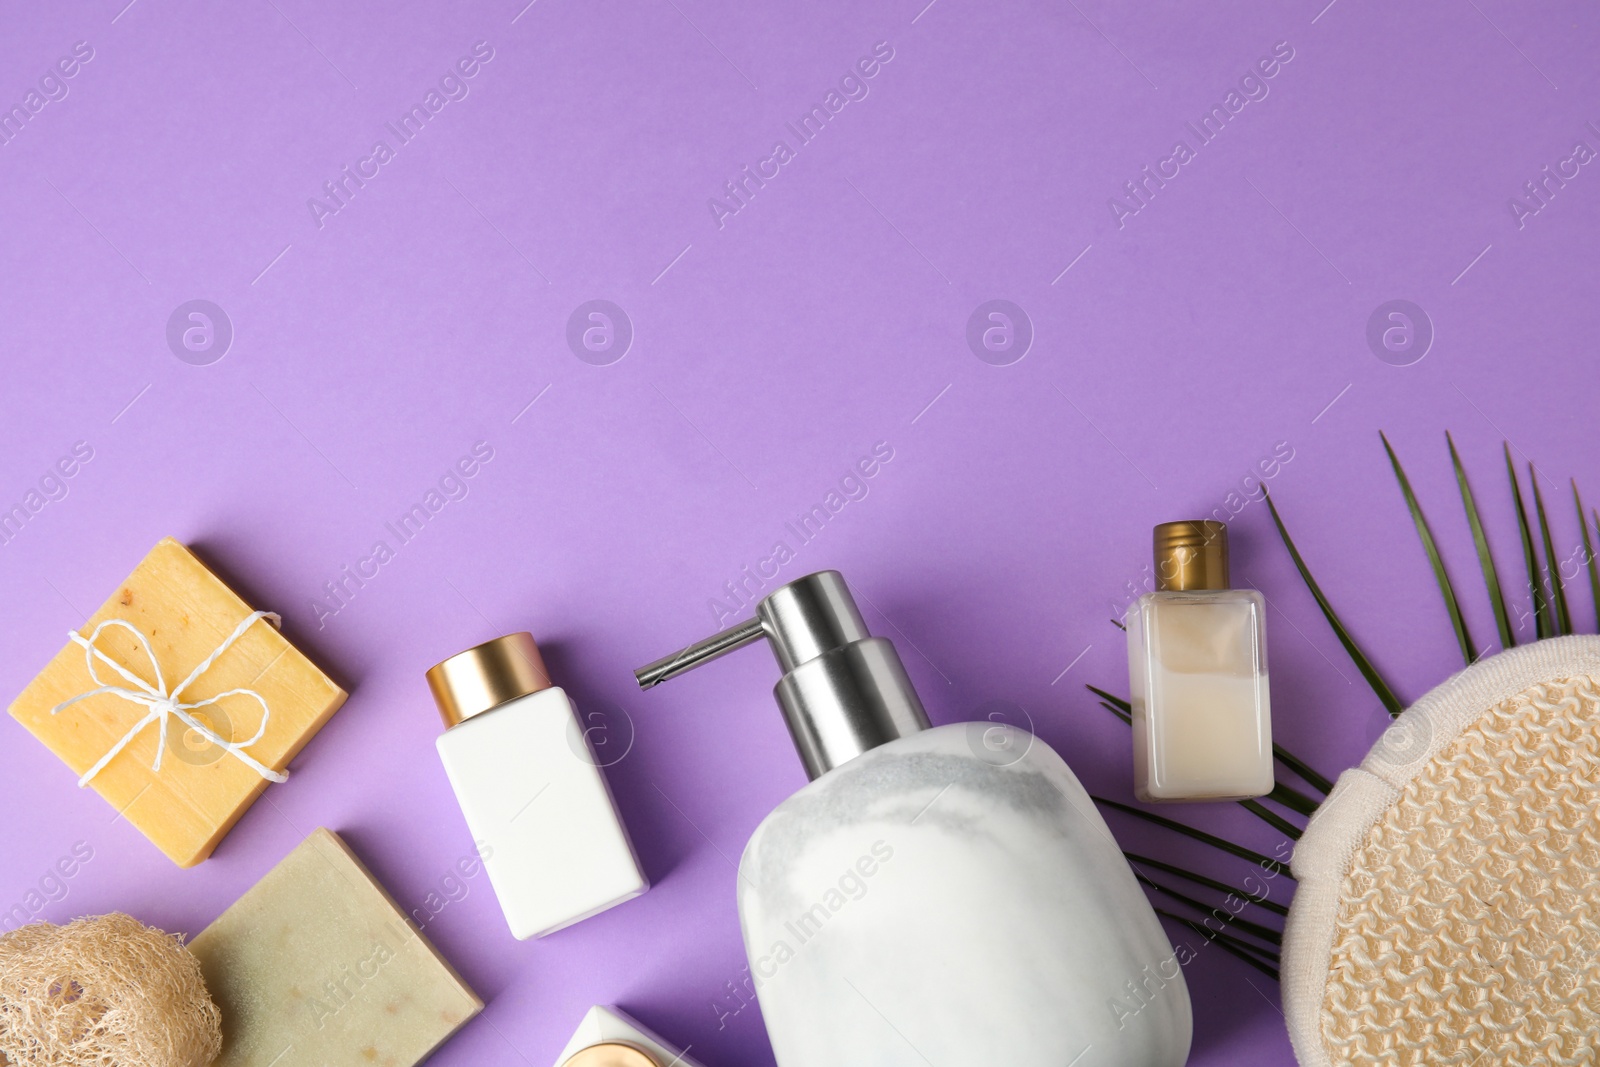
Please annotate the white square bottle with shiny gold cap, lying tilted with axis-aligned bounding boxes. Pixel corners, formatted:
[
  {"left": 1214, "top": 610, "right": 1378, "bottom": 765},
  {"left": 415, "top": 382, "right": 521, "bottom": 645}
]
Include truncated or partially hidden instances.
[{"left": 427, "top": 633, "right": 650, "bottom": 939}]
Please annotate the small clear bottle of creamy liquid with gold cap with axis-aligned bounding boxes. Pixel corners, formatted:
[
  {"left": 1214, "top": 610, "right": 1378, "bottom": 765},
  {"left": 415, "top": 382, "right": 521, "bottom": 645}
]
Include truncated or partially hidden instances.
[{"left": 1126, "top": 520, "right": 1274, "bottom": 801}]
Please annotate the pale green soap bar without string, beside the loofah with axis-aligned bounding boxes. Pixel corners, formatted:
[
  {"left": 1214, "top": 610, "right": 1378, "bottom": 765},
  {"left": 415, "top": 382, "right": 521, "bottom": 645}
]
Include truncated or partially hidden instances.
[{"left": 189, "top": 830, "right": 483, "bottom": 1067}]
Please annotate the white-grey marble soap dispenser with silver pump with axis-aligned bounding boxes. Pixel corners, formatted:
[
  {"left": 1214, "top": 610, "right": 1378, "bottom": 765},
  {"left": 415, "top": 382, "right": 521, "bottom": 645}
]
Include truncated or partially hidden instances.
[{"left": 637, "top": 571, "right": 1192, "bottom": 1067}]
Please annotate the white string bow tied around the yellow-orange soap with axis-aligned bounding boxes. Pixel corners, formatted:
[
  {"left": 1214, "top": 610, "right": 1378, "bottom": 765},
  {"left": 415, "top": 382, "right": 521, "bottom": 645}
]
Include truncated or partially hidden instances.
[{"left": 50, "top": 611, "right": 290, "bottom": 789}]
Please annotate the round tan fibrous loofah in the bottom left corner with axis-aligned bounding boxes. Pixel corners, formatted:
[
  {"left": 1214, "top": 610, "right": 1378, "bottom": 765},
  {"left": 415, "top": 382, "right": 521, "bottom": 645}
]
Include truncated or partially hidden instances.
[{"left": 0, "top": 915, "right": 222, "bottom": 1067}]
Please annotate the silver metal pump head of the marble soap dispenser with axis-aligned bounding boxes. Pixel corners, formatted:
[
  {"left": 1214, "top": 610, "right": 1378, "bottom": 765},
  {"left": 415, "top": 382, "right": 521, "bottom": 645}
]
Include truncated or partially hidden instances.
[{"left": 634, "top": 571, "right": 930, "bottom": 779}]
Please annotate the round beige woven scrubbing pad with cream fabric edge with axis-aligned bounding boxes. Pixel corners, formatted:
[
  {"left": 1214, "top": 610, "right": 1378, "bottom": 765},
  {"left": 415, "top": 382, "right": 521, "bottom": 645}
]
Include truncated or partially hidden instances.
[{"left": 1283, "top": 637, "right": 1600, "bottom": 1067}]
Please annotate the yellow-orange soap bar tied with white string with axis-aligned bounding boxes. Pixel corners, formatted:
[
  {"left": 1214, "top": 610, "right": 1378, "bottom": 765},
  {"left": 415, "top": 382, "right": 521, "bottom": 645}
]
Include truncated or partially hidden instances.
[{"left": 11, "top": 537, "right": 344, "bottom": 867}]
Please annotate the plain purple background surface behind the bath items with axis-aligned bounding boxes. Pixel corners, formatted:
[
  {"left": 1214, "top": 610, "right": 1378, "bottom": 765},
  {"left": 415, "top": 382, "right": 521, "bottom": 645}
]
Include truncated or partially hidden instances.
[{"left": 0, "top": 0, "right": 1600, "bottom": 1067}]
